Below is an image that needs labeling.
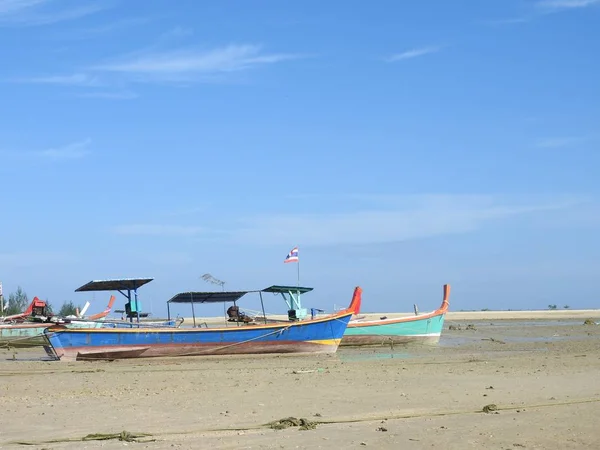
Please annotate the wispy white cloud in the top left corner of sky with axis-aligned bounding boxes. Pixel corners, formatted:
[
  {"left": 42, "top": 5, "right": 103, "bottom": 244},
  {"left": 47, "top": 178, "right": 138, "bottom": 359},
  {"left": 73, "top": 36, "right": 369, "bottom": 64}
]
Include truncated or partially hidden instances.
[{"left": 0, "top": 0, "right": 107, "bottom": 26}]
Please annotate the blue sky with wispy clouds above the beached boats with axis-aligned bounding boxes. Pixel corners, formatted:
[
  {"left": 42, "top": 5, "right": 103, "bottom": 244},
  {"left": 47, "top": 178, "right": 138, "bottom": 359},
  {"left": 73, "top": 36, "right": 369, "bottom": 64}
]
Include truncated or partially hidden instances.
[{"left": 0, "top": 0, "right": 600, "bottom": 315}]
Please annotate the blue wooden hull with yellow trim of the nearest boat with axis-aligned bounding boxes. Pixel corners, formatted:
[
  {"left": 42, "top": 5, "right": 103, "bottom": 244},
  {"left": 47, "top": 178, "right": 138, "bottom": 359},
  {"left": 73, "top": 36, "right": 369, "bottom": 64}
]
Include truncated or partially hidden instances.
[{"left": 45, "top": 312, "right": 352, "bottom": 361}]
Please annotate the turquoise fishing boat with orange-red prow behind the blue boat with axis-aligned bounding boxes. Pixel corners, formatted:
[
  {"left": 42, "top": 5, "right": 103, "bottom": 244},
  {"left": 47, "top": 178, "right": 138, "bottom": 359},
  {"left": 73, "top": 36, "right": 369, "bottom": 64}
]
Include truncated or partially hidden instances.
[{"left": 341, "top": 284, "right": 450, "bottom": 346}]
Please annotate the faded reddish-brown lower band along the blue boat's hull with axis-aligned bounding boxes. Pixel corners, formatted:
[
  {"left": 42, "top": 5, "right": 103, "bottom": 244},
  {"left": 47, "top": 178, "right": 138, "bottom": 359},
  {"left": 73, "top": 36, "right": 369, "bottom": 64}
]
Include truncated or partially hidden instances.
[{"left": 56, "top": 341, "right": 338, "bottom": 361}]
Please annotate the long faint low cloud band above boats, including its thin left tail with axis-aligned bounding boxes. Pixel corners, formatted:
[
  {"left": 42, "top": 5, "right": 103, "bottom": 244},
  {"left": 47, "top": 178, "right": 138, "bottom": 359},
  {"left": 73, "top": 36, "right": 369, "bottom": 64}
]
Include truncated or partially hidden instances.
[{"left": 112, "top": 195, "right": 582, "bottom": 245}]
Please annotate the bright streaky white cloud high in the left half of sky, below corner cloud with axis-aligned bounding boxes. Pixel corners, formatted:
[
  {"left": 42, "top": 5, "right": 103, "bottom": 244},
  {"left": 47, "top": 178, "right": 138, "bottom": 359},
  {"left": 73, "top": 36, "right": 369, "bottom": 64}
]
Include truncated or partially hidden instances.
[{"left": 90, "top": 44, "right": 308, "bottom": 81}]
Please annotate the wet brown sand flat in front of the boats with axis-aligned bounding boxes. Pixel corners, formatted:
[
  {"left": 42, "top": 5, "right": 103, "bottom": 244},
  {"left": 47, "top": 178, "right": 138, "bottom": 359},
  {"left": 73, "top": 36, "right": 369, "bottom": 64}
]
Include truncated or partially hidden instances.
[{"left": 0, "top": 317, "right": 600, "bottom": 450}]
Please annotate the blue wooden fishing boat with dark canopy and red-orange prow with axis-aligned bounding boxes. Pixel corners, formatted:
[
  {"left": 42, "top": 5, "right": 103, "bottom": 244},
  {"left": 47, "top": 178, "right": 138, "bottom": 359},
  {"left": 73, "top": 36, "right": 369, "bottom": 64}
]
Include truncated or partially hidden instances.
[{"left": 45, "top": 286, "right": 362, "bottom": 361}]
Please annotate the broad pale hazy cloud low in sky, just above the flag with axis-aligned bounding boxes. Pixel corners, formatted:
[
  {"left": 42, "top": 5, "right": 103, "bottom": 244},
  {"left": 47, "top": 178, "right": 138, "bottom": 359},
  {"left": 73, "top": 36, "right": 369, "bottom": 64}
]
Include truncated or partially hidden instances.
[{"left": 214, "top": 195, "right": 579, "bottom": 245}]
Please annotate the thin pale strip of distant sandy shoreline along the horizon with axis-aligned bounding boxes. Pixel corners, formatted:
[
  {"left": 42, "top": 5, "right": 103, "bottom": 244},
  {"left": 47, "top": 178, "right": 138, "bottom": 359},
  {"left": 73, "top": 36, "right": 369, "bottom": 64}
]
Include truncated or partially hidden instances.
[{"left": 171, "top": 309, "right": 600, "bottom": 324}]
